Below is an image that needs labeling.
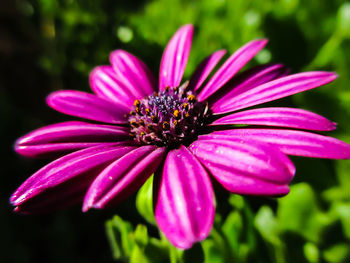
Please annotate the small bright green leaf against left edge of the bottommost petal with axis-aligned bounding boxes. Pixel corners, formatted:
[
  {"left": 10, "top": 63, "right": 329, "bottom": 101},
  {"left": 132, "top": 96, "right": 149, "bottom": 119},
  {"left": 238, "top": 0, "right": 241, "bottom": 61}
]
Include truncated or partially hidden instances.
[{"left": 136, "top": 175, "right": 156, "bottom": 225}]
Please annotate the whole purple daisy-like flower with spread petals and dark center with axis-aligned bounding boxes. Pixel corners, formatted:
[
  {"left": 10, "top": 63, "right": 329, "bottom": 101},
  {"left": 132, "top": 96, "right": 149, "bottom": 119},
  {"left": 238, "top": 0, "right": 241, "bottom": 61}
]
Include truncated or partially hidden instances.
[{"left": 11, "top": 25, "right": 350, "bottom": 248}]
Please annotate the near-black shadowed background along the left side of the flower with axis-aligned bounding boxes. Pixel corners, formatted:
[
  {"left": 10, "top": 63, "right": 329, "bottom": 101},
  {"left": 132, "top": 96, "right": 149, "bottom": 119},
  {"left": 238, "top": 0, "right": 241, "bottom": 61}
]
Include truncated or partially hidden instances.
[{"left": 0, "top": 0, "right": 150, "bottom": 263}]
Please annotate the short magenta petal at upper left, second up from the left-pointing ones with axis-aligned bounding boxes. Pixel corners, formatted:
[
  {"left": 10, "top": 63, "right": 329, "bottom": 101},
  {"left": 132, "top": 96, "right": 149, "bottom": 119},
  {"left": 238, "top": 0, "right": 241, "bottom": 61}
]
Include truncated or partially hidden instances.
[{"left": 89, "top": 66, "right": 139, "bottom": 106}]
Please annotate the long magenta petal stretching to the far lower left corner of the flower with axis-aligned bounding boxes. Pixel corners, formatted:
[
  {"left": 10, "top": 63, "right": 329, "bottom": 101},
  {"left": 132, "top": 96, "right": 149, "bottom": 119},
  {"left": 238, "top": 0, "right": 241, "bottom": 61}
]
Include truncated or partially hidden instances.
[{"left": 10, "top": 145, "right": 135, "bottom": 206}]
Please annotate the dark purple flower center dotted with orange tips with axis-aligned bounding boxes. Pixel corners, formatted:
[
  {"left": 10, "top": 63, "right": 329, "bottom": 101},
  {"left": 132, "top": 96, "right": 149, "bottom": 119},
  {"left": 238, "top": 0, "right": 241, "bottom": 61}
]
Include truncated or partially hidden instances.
[{"left": 129, "top": 83, "right": 210, "bottom": 148}]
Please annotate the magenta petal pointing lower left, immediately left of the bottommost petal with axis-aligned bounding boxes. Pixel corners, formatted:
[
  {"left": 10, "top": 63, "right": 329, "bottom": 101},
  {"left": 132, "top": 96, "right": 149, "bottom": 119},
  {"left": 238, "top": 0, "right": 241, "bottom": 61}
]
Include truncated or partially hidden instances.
[{"left": 83, "top": 145, "right": 166, "bottom": 212}]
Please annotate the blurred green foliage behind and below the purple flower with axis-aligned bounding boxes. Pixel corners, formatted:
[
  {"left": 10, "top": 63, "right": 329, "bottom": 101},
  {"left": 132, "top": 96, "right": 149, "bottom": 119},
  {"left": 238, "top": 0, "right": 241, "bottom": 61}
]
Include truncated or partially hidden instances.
[{"left": 6, "top": 0, "right": 350, "bottom": 263}]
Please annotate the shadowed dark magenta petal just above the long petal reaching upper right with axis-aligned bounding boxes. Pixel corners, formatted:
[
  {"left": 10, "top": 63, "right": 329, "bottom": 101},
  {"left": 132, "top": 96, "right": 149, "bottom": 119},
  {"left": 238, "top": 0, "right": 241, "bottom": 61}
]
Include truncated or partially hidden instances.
[{"left": 210, "top": 64, "right": 289, "bottom": 114}]
